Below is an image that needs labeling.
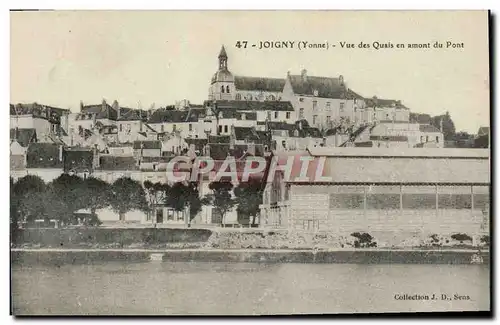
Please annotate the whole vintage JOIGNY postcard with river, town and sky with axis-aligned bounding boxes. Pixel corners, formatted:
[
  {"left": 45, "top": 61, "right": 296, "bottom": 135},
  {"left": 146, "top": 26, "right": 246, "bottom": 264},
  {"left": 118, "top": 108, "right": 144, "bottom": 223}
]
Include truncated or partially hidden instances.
[{"left": 10, "top": 11, "right": 491, "bottom": 316}]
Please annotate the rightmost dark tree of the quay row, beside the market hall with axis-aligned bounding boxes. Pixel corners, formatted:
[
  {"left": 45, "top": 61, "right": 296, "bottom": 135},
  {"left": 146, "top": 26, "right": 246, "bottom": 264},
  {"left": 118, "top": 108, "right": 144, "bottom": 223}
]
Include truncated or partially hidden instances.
[{"left": 234, "top": 180, "right": 263, "bottom": 224}]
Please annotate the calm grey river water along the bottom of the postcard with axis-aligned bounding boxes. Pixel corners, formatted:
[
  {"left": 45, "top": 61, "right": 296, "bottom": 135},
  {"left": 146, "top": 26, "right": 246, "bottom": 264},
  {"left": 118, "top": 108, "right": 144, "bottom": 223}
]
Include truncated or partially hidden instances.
[{"left": 11, "top": 262, "right": 490, "bottom": 315}]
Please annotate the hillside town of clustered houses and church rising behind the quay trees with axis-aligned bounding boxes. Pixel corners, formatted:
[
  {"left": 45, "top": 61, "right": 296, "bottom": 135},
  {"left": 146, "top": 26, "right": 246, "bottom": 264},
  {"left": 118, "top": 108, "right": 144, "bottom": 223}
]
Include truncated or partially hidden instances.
[{"left": 10, "top": 46, "right": 489, "bottom": 229}]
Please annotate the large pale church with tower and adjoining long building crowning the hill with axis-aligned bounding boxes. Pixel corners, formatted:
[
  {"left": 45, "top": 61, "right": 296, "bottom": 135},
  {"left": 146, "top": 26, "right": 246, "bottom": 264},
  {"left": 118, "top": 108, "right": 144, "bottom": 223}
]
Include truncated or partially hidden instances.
[{"left": 208, "top": 46, "right": 410, "bottom": 129}]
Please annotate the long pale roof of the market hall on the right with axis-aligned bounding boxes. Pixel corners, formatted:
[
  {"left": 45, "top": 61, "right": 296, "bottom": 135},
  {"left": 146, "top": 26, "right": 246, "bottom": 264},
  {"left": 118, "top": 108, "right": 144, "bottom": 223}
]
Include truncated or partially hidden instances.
[{"left": 278, "top": 148, "right": 491, "bottom": 185}]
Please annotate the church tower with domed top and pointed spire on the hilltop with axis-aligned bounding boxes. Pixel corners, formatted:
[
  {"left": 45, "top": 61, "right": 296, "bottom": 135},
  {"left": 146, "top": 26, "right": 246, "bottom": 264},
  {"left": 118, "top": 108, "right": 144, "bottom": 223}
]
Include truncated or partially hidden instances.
[{"left": 208, "top": 45, "right": 236, "bottom": 100}]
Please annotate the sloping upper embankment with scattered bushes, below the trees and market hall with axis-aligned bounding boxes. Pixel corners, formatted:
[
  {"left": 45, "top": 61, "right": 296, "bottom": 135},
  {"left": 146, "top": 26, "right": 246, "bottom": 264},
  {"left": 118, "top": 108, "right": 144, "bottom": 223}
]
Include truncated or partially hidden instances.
[{"left": 11, "top": 228, "right": 489, "bottom": 250}]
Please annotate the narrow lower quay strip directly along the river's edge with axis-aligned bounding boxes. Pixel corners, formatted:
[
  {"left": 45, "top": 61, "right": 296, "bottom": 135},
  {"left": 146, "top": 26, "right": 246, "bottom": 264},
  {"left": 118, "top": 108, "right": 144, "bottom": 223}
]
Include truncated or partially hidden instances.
[{"left": 11, "top": 248, "right": 490, "bottom": 265}]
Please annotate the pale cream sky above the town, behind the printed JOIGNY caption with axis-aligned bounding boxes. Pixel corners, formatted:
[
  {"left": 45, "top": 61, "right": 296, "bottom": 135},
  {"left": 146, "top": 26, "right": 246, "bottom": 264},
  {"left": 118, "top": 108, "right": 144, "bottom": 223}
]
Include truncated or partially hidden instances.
[{"left": 10, "top": 11, "right": 490, "bottom": 133}]
